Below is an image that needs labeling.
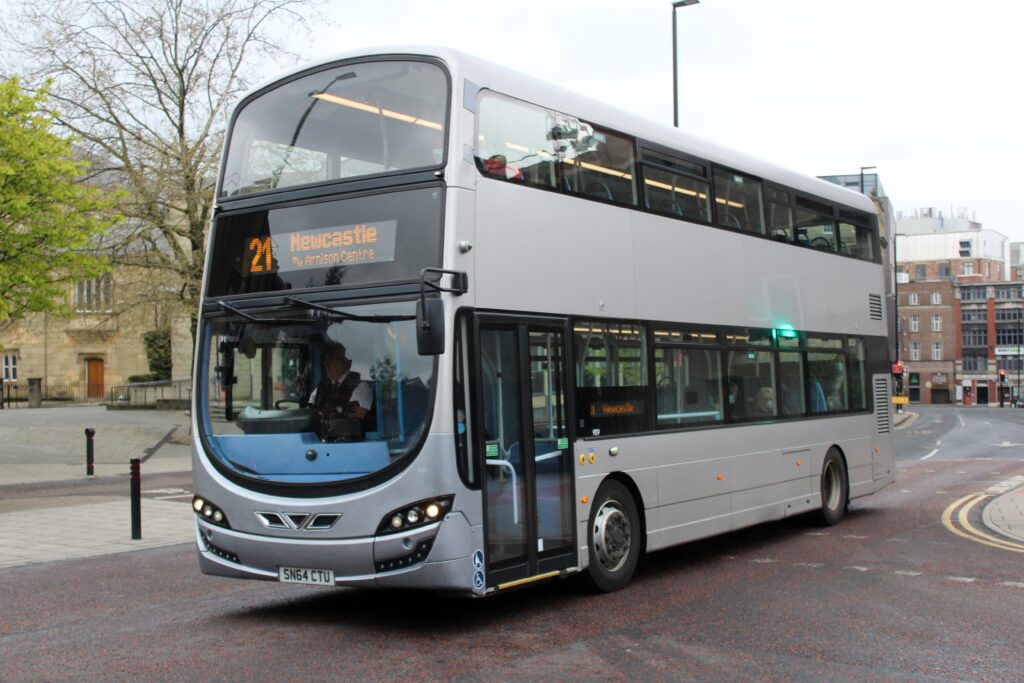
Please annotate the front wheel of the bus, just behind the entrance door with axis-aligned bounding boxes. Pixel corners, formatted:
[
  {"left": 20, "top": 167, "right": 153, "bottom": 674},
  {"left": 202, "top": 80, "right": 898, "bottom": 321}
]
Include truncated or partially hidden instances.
[{"left": 584, "top": 479, "right": 643, "bottom": 593}]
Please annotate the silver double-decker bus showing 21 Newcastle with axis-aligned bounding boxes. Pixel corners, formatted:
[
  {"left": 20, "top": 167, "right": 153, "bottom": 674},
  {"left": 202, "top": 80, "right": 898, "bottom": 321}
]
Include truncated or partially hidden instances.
[{"left": 193, "top": 46, "right": 895, "bottom": 596}]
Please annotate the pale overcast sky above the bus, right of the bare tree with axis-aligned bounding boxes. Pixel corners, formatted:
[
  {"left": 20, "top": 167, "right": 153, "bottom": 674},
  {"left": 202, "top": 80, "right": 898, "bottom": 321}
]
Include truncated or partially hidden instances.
[{"left": 290, "top": 0, "right": 1024, "bottom": 240}]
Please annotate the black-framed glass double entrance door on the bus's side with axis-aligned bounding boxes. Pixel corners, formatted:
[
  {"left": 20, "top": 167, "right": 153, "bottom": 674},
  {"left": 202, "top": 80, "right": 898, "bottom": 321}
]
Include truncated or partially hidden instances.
[{"left": 474, "top": 316, "right": 577, "bottom": 589}]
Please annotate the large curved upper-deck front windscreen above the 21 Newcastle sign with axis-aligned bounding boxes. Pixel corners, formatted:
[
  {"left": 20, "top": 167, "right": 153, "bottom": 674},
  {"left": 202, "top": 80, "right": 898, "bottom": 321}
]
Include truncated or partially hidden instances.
[{"left": 220, "top": 61, "right": 449, "bottom": 197}]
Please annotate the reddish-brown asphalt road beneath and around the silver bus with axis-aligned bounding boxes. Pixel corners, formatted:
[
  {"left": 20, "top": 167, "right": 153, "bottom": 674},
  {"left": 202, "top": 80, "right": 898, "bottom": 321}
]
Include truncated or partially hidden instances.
[{"left": 0, "top": 409, "right": 1024, "bottom": 681}]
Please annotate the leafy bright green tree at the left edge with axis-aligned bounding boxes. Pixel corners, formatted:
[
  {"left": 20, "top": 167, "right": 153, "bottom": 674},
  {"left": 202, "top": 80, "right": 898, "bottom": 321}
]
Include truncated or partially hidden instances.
[{"left": 0, "top": 79, "right": 116, "bottom": 321}]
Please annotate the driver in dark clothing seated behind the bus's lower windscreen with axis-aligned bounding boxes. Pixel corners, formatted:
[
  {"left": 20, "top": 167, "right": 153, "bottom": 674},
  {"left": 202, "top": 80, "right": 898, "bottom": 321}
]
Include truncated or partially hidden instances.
[{"left": 309, "top": 343, "right": 374, "bottom": 441}]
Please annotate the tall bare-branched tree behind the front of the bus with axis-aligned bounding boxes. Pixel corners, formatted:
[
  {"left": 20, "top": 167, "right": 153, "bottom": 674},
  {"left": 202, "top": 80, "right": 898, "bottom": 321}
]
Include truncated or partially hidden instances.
[{"left": 5, "top": 0, "right": 317, "bottom": 339}]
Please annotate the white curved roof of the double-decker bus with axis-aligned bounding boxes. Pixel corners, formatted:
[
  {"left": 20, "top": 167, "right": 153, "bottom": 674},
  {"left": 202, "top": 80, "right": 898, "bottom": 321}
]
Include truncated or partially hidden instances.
[{"left": 246, "top": 44, "right": 876, "bottom": 213}]
